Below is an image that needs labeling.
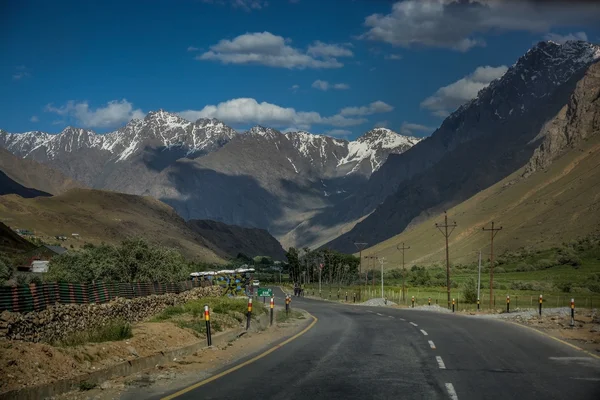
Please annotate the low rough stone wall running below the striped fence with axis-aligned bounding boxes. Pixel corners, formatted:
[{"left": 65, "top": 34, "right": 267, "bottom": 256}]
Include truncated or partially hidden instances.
[{"left": 0, "top": 286, "right": 222, "bottom": 343}]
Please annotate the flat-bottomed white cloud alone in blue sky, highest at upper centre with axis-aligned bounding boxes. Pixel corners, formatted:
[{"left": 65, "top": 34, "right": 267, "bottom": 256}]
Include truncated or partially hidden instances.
[{"left": 196, "top": 32, "right": 344, "bottom": 69}]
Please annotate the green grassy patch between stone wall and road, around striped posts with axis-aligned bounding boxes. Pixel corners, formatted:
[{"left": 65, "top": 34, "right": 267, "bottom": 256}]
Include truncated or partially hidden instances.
[{"left": 151, "top": 297, "right": 267, "bottom": 337}]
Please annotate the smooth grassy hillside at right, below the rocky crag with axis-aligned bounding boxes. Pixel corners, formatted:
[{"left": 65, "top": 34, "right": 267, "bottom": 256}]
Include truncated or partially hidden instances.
[{"left": 363, "top": 131, "right": 600, "bottom": 270}]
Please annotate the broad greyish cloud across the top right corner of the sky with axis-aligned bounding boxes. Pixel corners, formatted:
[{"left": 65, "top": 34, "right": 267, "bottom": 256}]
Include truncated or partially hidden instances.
[{"left": 360, "top": 0, "right": 600, "bottom": 52}]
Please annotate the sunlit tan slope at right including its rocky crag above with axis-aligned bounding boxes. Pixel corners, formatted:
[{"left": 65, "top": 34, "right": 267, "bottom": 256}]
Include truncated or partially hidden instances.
[{"left": 366, "top": 63, "right": 600, "bottom": 266}]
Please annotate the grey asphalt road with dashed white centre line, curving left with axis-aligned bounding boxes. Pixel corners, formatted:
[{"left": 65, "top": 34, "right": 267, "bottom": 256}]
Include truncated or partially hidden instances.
[{"left": 163, "top": 289, "right": 600, "bottom": 400}]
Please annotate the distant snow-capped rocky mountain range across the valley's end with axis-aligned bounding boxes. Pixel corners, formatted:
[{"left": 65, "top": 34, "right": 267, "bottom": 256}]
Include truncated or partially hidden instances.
[{"left": 0, "top": 110, "right": 420, "bottom": 241}]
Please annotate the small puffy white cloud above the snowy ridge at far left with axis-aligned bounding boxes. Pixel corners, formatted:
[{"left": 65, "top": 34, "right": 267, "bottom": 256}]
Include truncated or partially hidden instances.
[{"left": 45, "top": 99, "right": 144, "bottom": 128}]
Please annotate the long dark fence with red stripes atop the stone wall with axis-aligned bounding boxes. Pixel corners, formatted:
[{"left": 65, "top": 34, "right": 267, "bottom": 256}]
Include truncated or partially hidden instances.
[{"left": 0, "top": 281, "right": 211, "bottom": 312}]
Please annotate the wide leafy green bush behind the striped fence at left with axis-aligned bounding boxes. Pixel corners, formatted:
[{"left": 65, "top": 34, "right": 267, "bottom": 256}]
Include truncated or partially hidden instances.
[{"left": 45, "top": 239, "right": 191, "bottom": 282}]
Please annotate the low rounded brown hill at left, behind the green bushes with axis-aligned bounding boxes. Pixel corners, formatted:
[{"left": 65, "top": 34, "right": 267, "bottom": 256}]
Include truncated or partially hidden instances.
[{"left": 0, "top": 189, "right": 226, "bottom": 263}]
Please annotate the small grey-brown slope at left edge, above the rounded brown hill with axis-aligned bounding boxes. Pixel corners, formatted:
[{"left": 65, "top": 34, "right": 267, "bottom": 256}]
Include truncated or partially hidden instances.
[{"left": 0, "top": 148, "right": 81, "bottom": 197}]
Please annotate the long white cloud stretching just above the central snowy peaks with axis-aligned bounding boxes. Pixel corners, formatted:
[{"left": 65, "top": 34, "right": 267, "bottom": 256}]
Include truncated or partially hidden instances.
[{"left": 178, "top": 98, "right": 393, "bottom": 129}]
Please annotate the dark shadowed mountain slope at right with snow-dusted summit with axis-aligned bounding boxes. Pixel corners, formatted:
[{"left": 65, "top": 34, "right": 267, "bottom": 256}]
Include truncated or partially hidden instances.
[{"left": 324, "top": 42, "right": 600, "bottom": 251}]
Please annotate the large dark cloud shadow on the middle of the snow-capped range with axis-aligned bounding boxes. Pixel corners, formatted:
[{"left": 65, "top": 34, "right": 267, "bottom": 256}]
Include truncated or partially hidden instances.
[{"left": 161, "top": 160, "right": 283, "bottom": 233}]
